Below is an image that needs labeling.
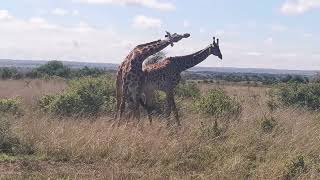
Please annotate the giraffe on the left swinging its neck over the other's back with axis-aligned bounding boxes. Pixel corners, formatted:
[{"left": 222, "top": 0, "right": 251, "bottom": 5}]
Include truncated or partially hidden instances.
[{"left": 115, "top": 32, "right": 190, "bottom": 124}]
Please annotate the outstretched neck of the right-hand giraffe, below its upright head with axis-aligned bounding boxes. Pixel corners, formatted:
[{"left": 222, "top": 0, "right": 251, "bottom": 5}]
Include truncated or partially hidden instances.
[{"left": 173, "top": 46, "right": 211, "bottom": 72}]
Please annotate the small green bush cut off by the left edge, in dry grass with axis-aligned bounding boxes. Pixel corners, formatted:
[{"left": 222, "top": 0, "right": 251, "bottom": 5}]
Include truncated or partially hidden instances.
[{"left": 0, "top": 99, "right": 22, "bottom": 115}]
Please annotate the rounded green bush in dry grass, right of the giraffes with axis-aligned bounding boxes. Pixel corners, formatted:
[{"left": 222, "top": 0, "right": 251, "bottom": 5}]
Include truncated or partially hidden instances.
[{"left": 194, "top": 89, "right": 241, "bottom": 118}]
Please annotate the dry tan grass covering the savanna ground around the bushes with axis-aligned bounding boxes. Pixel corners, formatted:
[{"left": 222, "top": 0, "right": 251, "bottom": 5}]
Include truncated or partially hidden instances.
[{"left": 0, "top": 80, "right": 320, "bottom": 179}]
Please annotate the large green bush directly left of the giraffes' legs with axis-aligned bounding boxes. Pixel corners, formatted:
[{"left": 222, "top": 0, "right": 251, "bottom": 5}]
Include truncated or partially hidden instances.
[{"left": 39, "top": 77, "right": 115, "bottom": 116}]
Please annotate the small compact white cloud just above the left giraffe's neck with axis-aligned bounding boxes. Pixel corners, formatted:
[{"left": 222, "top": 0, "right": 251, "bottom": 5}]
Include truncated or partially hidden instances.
[{"left": 133, "top": 15, "right": 162, "bottom": 29}]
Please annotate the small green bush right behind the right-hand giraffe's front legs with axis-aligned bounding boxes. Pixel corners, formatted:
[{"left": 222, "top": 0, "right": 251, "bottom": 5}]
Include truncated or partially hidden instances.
[{"left": 175, "top": 82, "right": 200, "bottom": 98}]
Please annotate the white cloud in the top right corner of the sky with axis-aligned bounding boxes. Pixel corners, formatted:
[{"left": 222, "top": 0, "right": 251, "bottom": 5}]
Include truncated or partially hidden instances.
[{"left": 281, "top": 0, "right": 320, "bottom": 15}]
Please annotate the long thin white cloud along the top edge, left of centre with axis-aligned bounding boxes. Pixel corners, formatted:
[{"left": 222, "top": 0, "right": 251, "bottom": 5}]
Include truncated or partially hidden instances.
[{"left": 72, "top": 0, "right": 175, "bottom": 11}]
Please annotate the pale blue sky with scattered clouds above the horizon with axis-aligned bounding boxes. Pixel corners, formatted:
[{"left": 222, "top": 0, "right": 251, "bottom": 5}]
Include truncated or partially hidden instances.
[{"left": 0, "top": 0, "right": 320, "bottom": 70}]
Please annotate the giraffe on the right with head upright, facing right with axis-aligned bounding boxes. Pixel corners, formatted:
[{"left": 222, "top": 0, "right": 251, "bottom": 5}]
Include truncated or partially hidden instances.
[{"left": 141, "top": 38, "right": 222, "bottom": 126}]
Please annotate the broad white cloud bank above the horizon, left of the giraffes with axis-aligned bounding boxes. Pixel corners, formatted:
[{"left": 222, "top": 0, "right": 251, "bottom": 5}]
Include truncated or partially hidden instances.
[{"left": 0, "top": 10, "right": 142, "bottom": 63}]
